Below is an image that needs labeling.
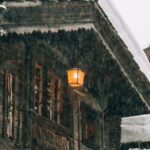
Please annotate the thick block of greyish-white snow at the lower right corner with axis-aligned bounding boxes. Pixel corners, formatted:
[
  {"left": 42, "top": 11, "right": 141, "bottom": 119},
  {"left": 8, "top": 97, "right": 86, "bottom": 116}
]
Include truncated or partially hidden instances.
[{"left": 121, "top": 115, "right": 150, "bottom": 143}]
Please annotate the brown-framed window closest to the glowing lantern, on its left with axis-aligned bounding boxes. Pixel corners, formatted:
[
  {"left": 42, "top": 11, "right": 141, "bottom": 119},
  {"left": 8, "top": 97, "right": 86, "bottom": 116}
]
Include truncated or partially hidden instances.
[{"left": 46, "top": 70, "right": 62, "bottom": 123}]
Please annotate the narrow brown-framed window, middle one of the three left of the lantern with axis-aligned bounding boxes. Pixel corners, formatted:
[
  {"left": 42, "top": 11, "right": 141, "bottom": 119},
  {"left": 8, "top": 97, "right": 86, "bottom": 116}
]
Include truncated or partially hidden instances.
[{"left": 34, "top": 65, "right": 43, "bottom": 115}]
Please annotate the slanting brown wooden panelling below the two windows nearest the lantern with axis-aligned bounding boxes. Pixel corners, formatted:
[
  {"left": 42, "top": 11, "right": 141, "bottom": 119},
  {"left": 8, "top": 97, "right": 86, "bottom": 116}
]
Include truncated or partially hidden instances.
[{"left": 31, "top": 112, "right": 73, "bottom": 150}]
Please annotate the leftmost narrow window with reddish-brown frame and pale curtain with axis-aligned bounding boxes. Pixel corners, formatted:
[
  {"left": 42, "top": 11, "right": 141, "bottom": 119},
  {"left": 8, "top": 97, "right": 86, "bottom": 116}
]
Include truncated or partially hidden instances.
[{"left": 3, "top": 72, "right": 16, "bottom": 138}]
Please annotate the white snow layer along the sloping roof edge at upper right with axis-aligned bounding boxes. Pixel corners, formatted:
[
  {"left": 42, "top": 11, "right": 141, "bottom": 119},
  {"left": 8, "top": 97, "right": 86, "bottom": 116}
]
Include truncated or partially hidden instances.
[{"left": 99, "top": 0, "right": 150, "bottom": 81}]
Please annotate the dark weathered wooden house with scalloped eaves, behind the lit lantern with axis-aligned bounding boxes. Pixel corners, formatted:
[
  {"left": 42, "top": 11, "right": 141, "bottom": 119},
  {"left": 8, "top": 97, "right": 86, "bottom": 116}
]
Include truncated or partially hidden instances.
[{"left": 0, "top": 0, "right": 150, "bottom": 150}]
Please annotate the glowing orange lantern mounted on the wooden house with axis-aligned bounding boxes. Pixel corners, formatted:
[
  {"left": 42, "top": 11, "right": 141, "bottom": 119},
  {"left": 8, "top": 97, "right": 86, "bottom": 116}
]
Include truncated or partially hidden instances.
[{"left": 67, "top": 68, "right": 85, "bottom": 88}]
